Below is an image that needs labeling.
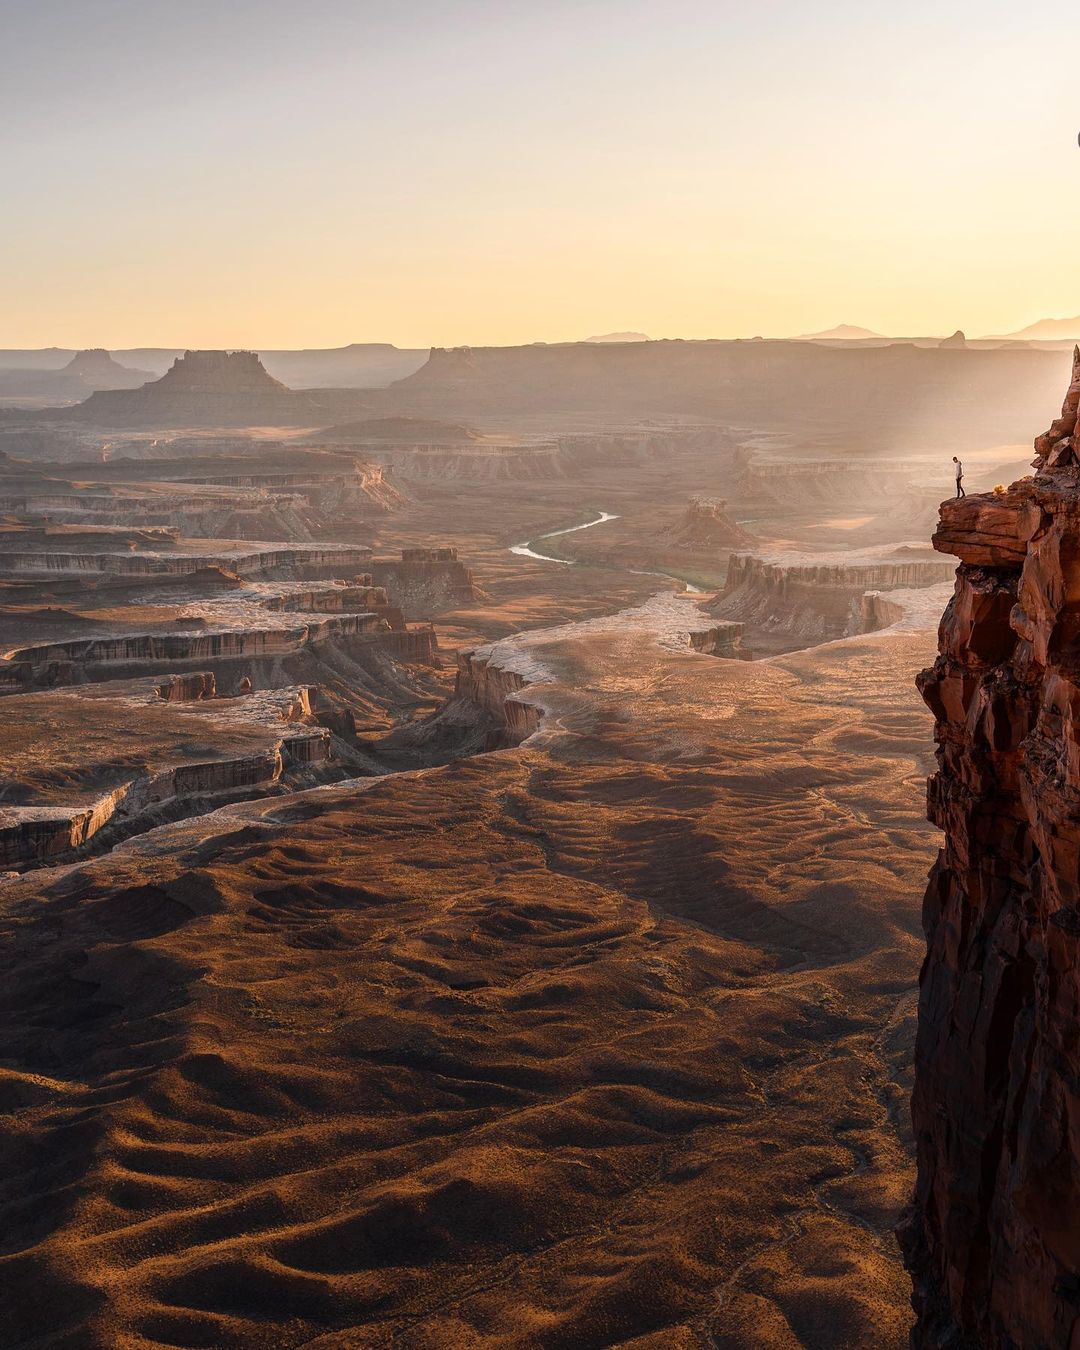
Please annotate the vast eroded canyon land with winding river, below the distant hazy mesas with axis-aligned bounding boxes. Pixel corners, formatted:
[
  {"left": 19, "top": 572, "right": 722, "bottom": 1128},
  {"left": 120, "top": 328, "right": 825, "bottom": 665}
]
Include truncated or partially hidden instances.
[{"left": 0, "top": 343, "right": 1057, "bottom": 1350}]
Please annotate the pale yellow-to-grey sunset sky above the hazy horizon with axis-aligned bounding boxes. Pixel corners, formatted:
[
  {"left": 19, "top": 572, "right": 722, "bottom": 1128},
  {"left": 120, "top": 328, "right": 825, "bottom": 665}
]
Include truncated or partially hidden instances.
[{"left": 0, "top": 0, "right": 1080, "bottom": 348}]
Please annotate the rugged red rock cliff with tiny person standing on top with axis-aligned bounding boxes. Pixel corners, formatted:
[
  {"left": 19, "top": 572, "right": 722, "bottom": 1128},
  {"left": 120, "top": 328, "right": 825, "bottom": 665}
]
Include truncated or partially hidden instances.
[{"left": 902, "top": 354, "right": 1080, "bottom": 1350}]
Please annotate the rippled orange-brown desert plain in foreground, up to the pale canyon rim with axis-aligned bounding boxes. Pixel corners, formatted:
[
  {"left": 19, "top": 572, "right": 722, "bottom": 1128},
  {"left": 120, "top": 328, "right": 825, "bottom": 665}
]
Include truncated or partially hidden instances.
[{"left": 0, "top": 556, "right": 937, "bottom": 1350}]
